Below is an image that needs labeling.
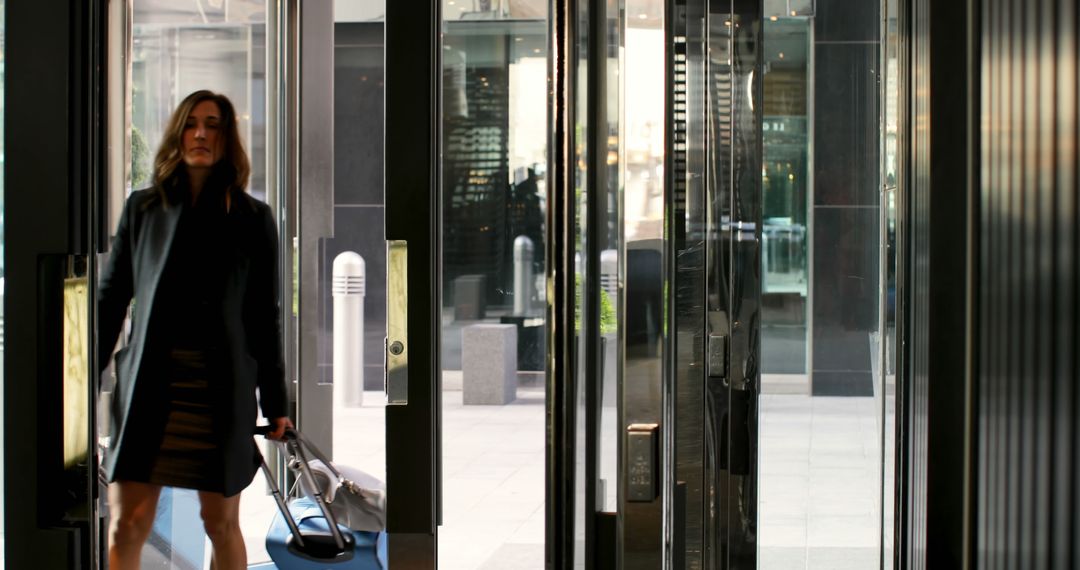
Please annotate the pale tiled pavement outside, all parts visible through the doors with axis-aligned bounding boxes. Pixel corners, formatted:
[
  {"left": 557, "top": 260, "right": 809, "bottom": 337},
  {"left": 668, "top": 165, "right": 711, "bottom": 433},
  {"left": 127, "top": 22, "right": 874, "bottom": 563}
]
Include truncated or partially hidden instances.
[{"left": 179, "top": 389, "right": 880, "bottom": 570}]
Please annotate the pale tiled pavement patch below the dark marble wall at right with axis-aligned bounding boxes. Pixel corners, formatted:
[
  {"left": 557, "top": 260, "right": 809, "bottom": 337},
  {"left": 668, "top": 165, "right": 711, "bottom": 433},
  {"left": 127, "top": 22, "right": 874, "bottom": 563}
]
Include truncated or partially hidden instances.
[{"left": 758, "top": 395, "right": 881, "bottom": 570}]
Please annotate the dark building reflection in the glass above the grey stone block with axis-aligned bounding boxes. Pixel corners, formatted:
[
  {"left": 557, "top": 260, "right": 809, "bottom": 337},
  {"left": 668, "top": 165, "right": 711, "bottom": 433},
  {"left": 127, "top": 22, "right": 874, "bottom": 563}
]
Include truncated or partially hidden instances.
[{"left": 442, "top": 22, "right": 544, "bottom": 306}]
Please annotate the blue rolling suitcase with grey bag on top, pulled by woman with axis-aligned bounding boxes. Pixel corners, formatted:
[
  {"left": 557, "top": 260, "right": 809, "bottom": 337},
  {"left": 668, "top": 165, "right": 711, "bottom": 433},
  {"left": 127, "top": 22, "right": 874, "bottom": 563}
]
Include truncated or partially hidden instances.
[{"left": 257, "top": 426, "right": 389, "bottom": 570}]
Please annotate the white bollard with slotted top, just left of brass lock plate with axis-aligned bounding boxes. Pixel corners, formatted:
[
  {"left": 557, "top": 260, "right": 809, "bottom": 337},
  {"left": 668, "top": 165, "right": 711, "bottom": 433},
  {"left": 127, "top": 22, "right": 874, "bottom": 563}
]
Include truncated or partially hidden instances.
[{"left": 332, "top": 252, "right": 367, "bottom": 408}]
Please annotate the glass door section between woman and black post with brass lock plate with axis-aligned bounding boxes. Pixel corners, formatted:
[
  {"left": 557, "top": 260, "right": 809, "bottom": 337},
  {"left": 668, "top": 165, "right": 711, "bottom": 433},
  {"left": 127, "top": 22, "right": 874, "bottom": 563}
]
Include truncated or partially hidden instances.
[{"left": 289, "top": 0, "right": 442, "bottom": 568}]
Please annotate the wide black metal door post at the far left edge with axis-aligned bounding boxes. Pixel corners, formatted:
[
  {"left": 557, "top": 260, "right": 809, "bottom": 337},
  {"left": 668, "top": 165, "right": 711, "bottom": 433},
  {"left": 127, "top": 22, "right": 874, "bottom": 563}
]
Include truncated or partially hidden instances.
[{"left": 3, "top": 0, "right": 105, "bottom": 568}]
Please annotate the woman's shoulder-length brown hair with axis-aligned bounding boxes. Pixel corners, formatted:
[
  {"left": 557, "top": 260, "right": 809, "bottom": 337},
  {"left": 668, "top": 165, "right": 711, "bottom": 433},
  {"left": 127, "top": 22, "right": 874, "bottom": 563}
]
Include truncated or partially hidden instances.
[{"left": 153, "top": 90, "right": 252, "bottom": 203}]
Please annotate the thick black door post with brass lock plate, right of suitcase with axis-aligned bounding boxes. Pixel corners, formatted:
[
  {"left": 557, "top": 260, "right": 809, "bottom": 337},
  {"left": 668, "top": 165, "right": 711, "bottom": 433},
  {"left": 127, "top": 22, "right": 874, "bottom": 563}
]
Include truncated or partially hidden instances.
[{"left": 383, "top": 2, "right": 442, "bottom": 569}]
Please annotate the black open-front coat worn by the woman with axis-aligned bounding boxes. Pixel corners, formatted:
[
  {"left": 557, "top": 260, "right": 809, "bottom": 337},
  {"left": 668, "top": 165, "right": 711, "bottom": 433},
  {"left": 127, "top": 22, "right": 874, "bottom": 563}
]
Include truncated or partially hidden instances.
[{"left": 97, "top": 189, "right": 288, "bottom": 497}]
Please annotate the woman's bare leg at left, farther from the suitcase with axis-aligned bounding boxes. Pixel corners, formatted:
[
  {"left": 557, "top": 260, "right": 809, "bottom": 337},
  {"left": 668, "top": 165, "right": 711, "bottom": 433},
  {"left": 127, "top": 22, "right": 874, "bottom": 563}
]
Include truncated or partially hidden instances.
[{"left": 109, "top": 481, "right": 161, "bottom": 570}]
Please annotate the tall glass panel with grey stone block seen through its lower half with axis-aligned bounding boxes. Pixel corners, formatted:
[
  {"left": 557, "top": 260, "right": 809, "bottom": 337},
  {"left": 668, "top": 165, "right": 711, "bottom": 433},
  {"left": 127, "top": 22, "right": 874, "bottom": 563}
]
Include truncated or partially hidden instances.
[{"left": 438, "top": 13, "right": 548, "bottom": 569}]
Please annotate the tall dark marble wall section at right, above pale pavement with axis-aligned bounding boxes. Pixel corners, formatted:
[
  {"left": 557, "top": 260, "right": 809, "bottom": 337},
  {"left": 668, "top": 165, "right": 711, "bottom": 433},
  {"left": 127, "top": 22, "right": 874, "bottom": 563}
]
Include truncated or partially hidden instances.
[{"left": 811, "top": 0, "right": 879, "bottom": 396}]
